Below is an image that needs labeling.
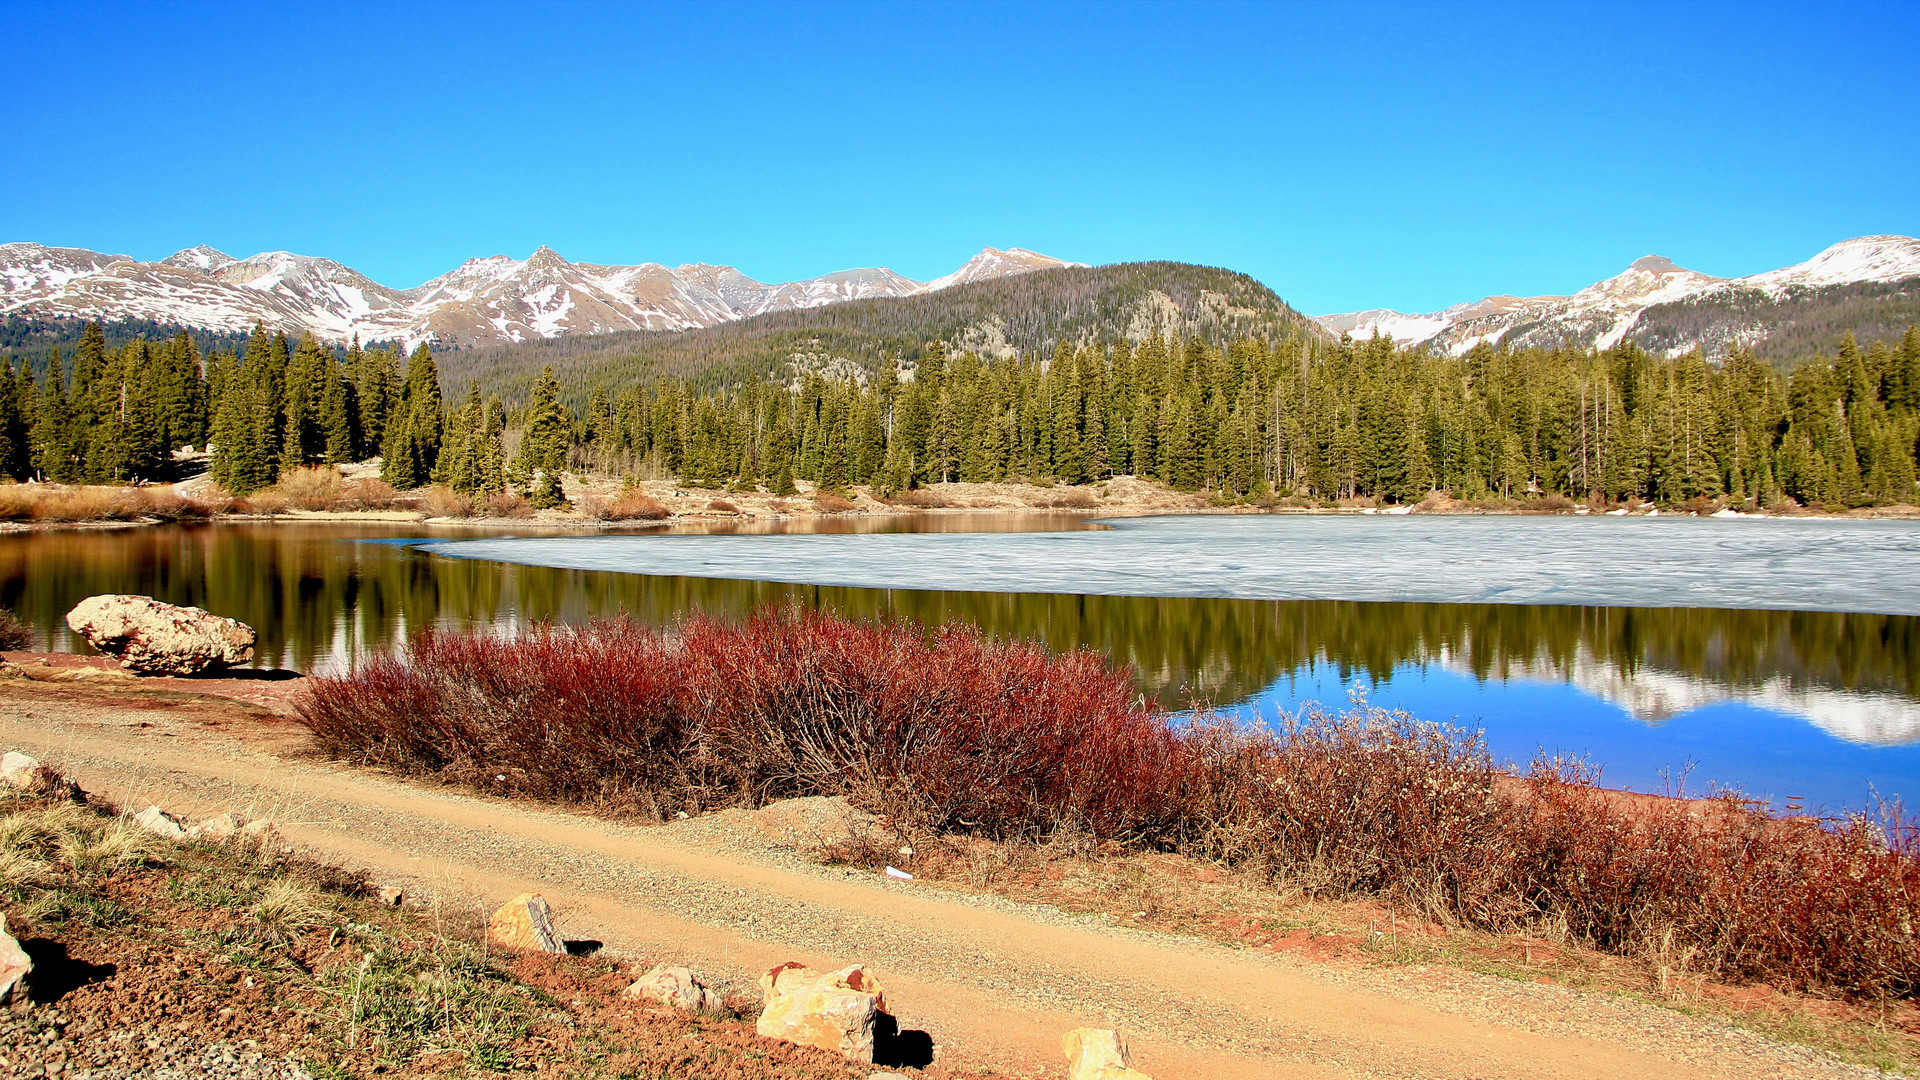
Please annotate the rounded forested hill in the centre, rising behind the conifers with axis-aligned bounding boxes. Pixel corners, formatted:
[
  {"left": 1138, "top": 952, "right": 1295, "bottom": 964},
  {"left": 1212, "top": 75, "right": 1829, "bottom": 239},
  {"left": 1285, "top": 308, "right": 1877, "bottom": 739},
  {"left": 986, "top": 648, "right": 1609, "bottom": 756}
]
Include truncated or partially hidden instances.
[{"left": 442, "top": 263, "right": 1325, "bottom": 407}]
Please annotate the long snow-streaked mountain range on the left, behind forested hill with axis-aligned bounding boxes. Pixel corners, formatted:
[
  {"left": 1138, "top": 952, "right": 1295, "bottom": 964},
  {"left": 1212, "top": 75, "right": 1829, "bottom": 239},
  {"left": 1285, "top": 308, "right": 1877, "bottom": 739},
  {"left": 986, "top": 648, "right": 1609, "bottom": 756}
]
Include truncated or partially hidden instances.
[{"left": 0, "top": 244, "right": 1083, "bottom": 346}]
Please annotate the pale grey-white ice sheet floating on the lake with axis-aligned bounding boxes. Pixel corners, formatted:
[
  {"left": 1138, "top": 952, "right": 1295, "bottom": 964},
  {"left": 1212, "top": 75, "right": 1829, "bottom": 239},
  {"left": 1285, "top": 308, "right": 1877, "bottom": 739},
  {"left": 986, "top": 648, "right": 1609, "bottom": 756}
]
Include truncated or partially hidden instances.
[{"left": 426, "top": 515, "right": 1920, "bottom": 615}]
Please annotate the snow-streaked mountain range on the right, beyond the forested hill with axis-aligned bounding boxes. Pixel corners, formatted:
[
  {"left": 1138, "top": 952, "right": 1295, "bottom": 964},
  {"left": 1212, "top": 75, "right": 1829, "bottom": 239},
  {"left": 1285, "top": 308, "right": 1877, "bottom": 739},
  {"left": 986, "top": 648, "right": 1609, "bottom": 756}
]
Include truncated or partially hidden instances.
[{"left": 1315, "top": 236, "right": 1920, "bottom": 357}]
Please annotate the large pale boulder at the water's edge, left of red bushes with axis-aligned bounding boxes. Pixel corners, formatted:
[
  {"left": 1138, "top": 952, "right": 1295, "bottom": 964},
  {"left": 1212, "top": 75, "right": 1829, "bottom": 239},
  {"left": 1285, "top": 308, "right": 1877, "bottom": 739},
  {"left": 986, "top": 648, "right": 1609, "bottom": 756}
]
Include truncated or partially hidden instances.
[{"left": 67, "top": 594, "right": 253, "bottom": 675}]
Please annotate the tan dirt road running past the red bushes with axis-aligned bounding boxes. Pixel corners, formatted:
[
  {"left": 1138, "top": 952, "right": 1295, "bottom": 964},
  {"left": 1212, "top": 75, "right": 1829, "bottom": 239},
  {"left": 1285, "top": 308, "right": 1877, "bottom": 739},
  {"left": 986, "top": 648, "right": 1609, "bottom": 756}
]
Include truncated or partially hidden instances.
[{"left": 0, "top": 678, "right": 1872, "bottom": 1080}]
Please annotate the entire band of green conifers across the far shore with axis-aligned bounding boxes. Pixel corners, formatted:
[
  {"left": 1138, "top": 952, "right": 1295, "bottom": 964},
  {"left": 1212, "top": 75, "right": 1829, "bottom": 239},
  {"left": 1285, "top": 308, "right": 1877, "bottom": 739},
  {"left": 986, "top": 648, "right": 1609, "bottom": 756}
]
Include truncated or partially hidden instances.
[{"left": 0, "top": 317, "right": 1920, "bottom": 509}]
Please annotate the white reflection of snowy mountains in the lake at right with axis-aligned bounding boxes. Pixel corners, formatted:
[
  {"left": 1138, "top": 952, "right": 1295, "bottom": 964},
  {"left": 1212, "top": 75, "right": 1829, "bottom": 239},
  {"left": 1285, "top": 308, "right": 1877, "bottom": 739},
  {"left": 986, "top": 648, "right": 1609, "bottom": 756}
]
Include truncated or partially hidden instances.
[{"left": 1440, "top": 650, "right": 1920, "bottom": 746}]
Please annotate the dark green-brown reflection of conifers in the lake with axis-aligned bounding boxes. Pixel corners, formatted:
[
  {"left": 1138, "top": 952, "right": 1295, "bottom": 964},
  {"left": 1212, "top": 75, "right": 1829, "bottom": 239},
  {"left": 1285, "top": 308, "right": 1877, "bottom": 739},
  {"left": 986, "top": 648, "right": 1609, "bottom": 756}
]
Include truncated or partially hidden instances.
[{"left": 0, "top": 525, "right": 1920, "bottom": 701}]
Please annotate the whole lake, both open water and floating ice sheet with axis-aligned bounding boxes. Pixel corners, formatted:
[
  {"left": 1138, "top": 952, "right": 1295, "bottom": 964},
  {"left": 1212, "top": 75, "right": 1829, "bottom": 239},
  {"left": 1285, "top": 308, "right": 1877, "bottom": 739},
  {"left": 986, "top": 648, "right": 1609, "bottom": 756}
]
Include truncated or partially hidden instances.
[{"left": 0, "top": 515, "right": 1920, "bottom": 811}]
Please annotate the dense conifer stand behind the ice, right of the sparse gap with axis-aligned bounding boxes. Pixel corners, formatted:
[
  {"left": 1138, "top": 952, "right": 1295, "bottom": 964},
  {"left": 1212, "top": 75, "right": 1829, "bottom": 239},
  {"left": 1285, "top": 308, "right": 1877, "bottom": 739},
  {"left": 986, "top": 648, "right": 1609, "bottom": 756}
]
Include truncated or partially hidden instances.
[{"left": 582, "top": 329, "right": 1920, "bottom": 505}]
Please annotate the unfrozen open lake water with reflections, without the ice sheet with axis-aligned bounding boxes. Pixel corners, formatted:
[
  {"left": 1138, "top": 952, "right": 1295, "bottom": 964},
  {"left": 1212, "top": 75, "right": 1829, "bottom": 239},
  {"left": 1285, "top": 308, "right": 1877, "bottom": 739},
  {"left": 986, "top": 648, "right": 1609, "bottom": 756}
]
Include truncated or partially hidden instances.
[{"left": 0, "top": 517, "right": 1920, "bottom": 801}]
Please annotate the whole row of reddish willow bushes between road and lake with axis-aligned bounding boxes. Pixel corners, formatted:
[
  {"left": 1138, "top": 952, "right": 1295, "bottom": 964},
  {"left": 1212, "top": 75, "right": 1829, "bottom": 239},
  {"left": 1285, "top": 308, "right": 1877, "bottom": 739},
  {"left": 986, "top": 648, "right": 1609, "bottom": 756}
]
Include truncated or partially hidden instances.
[{"left": 301, "top": 611, "right": 1920, "bottom": 997}]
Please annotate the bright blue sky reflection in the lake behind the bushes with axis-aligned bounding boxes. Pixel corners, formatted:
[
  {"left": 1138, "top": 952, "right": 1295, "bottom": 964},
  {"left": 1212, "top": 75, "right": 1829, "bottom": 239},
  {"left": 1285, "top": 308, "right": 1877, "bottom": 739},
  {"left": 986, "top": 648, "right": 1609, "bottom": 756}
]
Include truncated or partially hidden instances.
[{"left": 1235, "top": 663, "right": 1920, "bottom": 811}]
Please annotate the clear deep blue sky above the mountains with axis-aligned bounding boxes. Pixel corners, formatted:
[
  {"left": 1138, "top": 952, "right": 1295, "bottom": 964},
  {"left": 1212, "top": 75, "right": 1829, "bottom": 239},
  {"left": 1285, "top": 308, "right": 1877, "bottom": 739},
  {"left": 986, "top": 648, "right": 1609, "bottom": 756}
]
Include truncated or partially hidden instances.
[{"left": 0, "top": 4, "right": 1920, "bottom": 313}]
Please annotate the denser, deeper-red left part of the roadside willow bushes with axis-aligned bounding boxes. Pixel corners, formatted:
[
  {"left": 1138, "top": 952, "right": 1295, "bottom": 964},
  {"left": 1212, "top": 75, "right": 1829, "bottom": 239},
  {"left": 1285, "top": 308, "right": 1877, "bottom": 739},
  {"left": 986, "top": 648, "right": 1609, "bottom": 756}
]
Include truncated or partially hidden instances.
[{"left": 301, "top": 611, "right": 1183, "bottom": 842}]
